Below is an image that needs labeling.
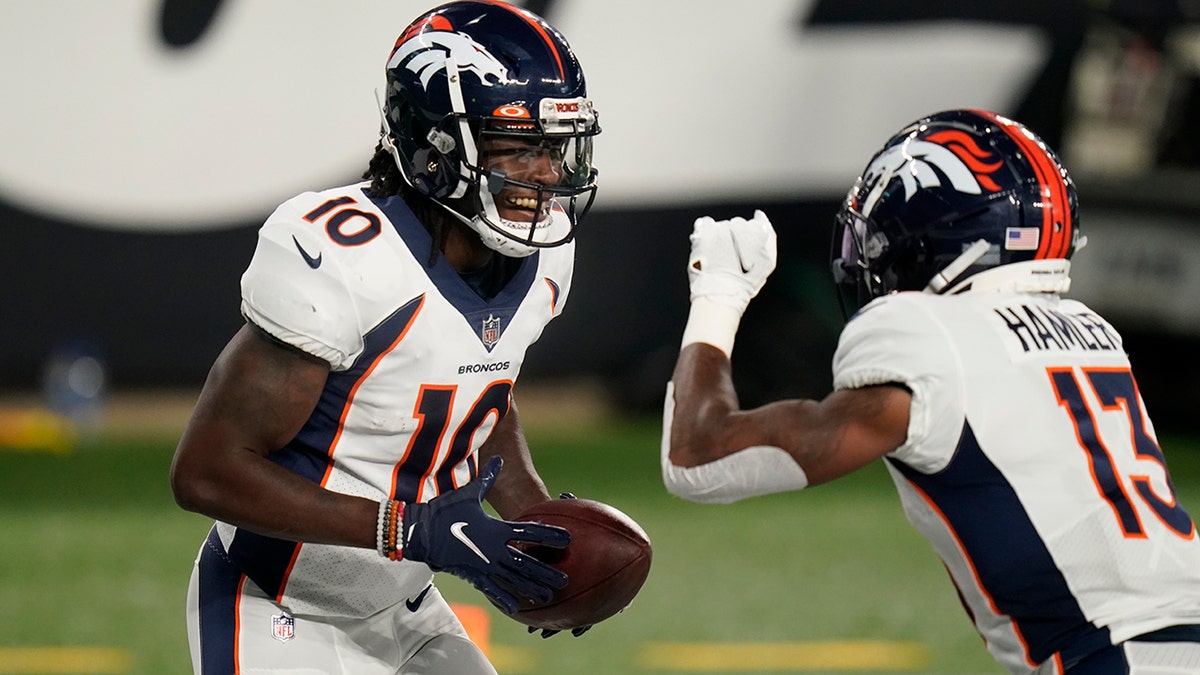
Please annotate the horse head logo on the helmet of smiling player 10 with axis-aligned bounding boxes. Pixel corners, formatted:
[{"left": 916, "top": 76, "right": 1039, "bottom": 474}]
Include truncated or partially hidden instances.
[{"left": 388, "top": 17, "right": 512, "bottom": 89}]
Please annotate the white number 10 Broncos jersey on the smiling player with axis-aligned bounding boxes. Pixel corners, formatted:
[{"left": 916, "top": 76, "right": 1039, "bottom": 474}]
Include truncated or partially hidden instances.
[{"left": 217, "top": 184, "right": 575, "bottom": 616}]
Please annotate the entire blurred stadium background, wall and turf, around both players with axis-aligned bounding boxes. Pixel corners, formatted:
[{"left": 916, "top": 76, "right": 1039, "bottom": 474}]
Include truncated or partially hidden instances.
[{"left": 0, "top": 0, "right": 1200, "bottom": 673}]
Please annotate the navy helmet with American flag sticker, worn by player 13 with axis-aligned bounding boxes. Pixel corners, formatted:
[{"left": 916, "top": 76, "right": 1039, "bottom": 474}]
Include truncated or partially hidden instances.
[{"left": 832, "top": 109, "right": 1084, "bottom": 316}]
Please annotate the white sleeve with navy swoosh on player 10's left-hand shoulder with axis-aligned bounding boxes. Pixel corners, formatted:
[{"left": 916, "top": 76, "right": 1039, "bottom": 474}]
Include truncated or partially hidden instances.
[{"left": 241, "top": 192, "right": 362, "bottom": 370}]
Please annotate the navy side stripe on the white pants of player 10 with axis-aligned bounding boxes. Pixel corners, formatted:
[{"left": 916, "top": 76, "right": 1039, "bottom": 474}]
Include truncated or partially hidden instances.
[{"left": 197, "top": 527, "right": 242, "bottom": 675}]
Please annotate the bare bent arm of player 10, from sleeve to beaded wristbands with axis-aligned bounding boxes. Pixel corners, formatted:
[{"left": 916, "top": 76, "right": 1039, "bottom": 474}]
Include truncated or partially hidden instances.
[{"left": 170, "top": 325, "right": 378, "bottom": 548}]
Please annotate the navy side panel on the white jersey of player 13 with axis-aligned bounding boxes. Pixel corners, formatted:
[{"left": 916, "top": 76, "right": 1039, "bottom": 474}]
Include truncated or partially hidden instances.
[{"left": 888, "top": 424, "right": 1109, "bottom": 664}]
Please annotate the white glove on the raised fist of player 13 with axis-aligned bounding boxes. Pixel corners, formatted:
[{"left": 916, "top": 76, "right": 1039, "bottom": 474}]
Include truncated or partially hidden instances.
[{"left": 688, "top": 210, "right": 775, "bottom": 315}]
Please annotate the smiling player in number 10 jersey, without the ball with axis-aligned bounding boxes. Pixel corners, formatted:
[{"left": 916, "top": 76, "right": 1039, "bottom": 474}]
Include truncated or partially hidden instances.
[{"left": 170, "top": 0, "right": 600, "bottom": 675}]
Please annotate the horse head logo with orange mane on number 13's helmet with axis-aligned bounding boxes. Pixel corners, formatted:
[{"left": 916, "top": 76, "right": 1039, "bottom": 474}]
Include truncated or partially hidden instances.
[{"left": 860, "top": 131, "right": 1004, "bottom": 215}]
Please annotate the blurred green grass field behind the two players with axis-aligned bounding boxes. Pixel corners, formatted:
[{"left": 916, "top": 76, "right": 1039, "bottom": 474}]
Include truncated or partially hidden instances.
[{"left": 0, "top": 401, "right": 1200, "bottom": 675}]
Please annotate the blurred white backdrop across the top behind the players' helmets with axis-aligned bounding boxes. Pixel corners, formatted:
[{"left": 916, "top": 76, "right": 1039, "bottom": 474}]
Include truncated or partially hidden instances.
[{"left": 0, "top": 0, "right": 1046, "bottom": 231}]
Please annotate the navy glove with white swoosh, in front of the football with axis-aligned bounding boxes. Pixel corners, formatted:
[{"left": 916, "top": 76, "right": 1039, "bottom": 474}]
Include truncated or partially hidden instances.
[{"left": 402, "top": 456, "right": 571, "bottom": 614}]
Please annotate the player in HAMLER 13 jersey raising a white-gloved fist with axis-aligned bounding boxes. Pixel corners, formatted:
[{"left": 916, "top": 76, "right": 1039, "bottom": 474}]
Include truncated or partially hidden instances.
[{"left": 661, "top": 109, "right": 1200, "bottom": 675}]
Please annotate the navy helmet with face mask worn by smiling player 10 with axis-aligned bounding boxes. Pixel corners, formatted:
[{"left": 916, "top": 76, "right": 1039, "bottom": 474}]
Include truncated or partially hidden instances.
[{"left": 383, "top": 0, "right": 600, "bottom": 257}]
